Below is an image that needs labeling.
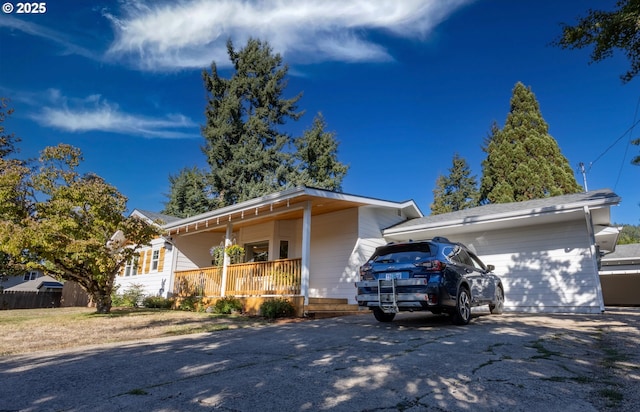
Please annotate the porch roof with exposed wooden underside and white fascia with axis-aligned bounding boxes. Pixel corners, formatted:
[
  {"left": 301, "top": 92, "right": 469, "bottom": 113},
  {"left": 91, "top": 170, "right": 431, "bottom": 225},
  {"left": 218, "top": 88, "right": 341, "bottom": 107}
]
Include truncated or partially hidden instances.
[{"left": 163, "top": 186, "right": 423, "bottom": 234}]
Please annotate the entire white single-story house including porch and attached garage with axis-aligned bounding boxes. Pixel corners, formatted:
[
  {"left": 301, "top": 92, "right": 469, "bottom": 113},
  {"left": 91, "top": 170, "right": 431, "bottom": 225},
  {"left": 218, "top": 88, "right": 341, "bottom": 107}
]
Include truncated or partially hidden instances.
[{"left": 117, "top": 186, "right": 620, "bottom": 313}]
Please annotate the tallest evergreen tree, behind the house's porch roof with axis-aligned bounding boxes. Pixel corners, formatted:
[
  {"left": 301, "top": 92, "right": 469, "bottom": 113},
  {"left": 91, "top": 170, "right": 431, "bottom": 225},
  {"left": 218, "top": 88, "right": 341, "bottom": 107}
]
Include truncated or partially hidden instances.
[{"left": 202, "top": 39, "right": 302, "bottom": 205}]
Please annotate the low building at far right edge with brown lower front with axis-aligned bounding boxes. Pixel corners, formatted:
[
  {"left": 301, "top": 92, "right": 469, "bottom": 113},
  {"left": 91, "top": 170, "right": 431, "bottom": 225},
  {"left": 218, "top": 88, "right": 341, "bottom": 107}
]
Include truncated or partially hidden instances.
[{"left": 600, "top": 243, "right": 640, "bottom": 306}]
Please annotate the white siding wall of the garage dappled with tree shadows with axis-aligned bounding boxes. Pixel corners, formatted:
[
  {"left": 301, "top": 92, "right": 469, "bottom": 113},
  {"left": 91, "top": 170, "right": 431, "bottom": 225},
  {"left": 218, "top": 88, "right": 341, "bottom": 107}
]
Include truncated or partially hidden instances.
[{"left": 443, "top": 220, "right": 601, "bottom": 313}]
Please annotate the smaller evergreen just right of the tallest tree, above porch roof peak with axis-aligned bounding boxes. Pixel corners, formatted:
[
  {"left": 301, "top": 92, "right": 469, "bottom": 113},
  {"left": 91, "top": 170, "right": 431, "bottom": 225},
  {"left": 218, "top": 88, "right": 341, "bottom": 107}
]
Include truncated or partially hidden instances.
[{"left": 292, "top": 113, "right": 349, "bottom": 191}]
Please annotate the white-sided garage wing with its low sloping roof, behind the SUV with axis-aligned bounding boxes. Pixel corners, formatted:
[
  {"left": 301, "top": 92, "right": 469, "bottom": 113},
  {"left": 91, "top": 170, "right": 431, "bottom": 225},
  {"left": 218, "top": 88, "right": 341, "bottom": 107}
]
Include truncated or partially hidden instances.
[{"left": 383, "top": 189, "right": 621, "bottom": 313}]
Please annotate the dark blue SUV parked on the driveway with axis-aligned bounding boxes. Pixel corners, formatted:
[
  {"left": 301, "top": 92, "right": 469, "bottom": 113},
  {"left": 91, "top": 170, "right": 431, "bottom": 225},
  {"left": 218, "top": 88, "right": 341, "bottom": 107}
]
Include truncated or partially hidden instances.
[{"left": 356, "top": 237, "right": 504, "bottom": 325}]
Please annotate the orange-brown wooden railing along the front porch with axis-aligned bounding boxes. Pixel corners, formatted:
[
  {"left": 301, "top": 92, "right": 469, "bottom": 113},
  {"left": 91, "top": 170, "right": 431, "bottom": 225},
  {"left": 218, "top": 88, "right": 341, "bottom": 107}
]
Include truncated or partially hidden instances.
[{"left": 173, "top": 259, "right": 302, "bottom": 297}]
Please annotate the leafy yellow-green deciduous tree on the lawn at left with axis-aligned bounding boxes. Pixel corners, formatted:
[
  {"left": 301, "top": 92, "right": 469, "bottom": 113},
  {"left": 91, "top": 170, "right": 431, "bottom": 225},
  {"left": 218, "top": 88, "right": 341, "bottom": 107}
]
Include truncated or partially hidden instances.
[{"left": 0, "top": 144, "right": 159, "bottom": 313}]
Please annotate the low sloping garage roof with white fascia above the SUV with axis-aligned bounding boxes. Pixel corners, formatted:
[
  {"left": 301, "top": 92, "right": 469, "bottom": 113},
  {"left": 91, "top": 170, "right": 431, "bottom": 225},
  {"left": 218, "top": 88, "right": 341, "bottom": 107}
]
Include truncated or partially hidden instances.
[{"left": 384, "top": 189, "right": 621, "bottom": 238}]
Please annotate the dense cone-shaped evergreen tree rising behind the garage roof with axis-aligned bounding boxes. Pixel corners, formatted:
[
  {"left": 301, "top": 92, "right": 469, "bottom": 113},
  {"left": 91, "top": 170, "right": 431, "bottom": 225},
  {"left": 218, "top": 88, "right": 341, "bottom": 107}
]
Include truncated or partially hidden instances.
[{"left": 480, "top": 82, "right": 582, "bottom": 203}]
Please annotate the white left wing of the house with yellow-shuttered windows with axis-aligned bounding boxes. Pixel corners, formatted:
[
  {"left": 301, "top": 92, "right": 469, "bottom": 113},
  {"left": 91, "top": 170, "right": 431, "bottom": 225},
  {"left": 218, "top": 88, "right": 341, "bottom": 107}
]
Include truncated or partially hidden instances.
[{"left": 115, "top": 209, "right": 178, "bottom": 297}]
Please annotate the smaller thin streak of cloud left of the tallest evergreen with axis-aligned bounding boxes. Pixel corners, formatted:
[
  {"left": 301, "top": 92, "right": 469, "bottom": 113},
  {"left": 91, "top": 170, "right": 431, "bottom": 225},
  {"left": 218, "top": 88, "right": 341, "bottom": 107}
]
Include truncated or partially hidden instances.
[{"left": 32, "top": 89, "right": 200, "bottom": 139}]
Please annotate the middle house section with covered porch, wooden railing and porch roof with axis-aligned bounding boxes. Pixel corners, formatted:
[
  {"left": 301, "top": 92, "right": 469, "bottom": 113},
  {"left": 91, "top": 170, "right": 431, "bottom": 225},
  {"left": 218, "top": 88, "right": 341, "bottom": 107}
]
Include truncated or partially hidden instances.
[{"left": 162, "top": 187, "right": 422, "bottom": 305}]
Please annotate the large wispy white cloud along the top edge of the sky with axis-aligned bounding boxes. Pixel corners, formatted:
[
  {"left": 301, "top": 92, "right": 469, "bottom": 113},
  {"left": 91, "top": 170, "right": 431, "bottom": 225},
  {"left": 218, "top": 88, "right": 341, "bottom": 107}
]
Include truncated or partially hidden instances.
[{"left": 103, "top": 0, "right": 473, "bottom": 70}]
